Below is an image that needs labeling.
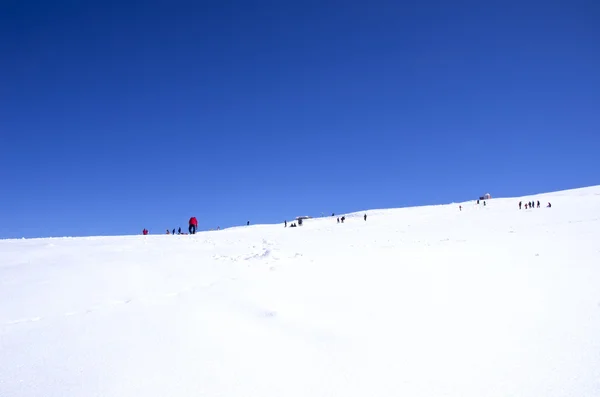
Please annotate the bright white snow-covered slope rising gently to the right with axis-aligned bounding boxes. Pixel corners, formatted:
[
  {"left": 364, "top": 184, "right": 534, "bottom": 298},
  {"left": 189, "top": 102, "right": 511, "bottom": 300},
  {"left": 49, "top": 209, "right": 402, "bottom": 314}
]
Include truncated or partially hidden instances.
[{"left": 0, "top": 187, "right": 600, "bottom": 397}]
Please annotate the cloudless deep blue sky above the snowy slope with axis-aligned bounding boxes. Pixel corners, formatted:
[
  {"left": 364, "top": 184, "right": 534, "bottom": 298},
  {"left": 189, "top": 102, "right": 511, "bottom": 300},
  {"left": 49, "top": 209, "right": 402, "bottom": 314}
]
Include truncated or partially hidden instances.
[{"left": 0, "top": 0, "right": 600, "bottom": 238}]
